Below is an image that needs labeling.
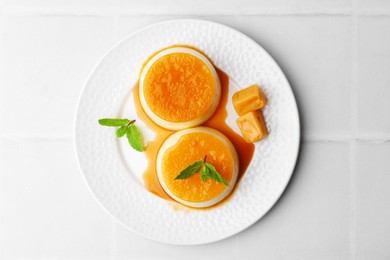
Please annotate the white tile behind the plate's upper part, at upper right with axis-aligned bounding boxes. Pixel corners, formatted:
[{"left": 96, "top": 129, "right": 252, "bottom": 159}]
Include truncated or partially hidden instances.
[{"left": 118, "top": 16, "right": 352, "bottom": 137}]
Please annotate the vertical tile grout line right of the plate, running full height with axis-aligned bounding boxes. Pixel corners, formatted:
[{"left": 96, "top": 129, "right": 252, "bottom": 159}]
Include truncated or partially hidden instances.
[{"left": 350, "top": 1, "right": 359, "bottom": 260}]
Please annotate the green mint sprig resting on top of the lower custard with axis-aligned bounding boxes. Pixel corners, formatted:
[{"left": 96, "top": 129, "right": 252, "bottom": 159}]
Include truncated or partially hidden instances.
[{"left": 175, "top": 155, "right": 229, "bottom": 186}]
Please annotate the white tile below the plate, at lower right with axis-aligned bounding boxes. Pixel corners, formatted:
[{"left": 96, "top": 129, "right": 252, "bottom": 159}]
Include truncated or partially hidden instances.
[{"left": 115, "top": 143, "right": 351, "bottom": 259}]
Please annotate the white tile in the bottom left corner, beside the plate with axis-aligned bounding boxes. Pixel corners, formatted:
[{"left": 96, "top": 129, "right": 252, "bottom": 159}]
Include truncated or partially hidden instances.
[{"left": 0, "top": 139, "right": 111, "bottom": 259}]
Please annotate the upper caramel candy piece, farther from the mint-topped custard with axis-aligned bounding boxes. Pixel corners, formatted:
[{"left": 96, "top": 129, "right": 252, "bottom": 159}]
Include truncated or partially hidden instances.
[{"left": 232, "top": 85, "right": 267, "bottom": 116}]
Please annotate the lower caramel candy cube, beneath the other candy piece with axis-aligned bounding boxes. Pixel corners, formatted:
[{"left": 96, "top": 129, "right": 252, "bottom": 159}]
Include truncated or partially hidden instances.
[{"left": 236, "top": 110, "right": 268, "bottom": 143}]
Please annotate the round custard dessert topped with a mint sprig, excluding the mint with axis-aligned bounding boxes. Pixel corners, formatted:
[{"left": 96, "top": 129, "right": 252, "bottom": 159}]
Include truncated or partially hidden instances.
[{"left": 156, "top": 127, "right": 239, "bottom": 208}]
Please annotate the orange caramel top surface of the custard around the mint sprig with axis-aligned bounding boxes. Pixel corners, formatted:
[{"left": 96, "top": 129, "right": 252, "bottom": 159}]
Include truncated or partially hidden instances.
[{"left": 162, "top": 132, "right": 234, "bottom": 202}]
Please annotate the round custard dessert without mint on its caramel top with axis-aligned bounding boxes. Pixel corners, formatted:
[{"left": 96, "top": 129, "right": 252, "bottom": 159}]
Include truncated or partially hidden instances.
[{"left": 139, "top": 47, "right": 221, "bottom": 130}]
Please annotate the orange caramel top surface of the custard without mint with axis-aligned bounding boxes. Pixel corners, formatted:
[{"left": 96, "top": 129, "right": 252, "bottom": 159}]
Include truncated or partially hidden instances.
[{"left": 143, "top": 52, "right": 215, "bottom": 122}]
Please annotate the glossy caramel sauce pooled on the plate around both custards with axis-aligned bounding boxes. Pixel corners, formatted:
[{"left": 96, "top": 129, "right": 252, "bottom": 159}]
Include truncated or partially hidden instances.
[{"left": 133, "top": 45, "right": 255, "bottom": 208}]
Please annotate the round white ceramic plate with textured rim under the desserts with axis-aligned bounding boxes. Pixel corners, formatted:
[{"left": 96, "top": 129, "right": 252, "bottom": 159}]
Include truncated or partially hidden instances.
[{"left": 75, "top": 20, "right": 300, "bottom": 245}]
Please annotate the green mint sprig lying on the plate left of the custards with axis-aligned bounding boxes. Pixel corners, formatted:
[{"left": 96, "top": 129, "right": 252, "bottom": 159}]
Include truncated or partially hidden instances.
[{"left": 99, "top": 118, "right": 144, "bottom": 152}]
